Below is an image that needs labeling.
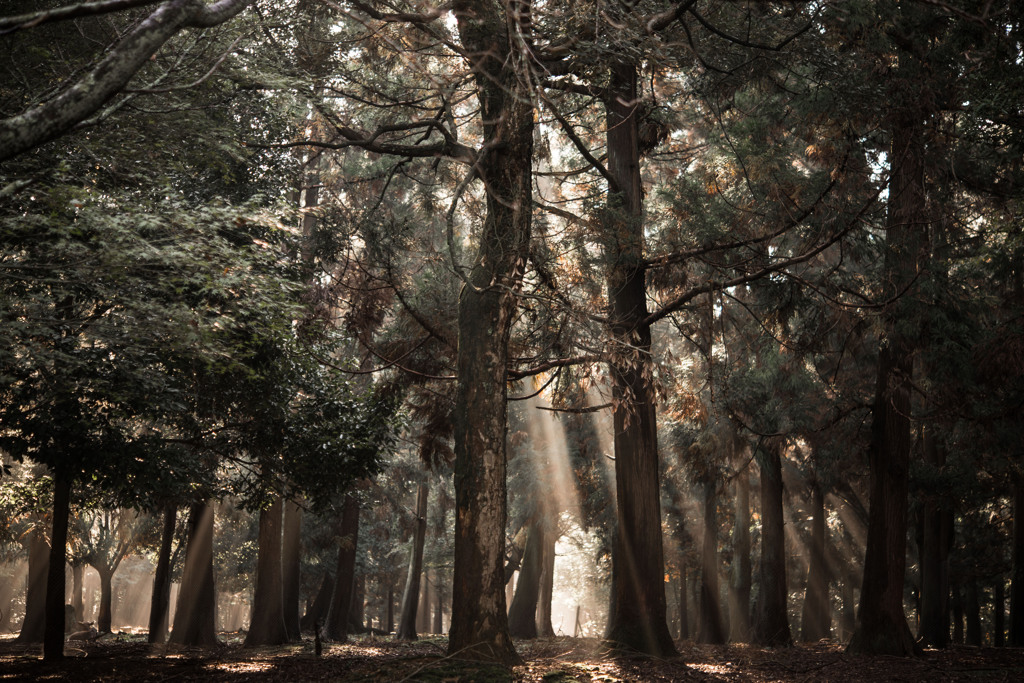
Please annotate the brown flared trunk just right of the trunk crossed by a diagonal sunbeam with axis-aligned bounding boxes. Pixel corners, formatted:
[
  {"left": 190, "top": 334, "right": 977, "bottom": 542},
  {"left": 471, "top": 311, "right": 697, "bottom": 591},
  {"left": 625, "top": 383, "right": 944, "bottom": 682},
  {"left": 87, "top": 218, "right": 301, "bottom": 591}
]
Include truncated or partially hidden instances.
[{"left": 245, "top": 497, "right": 288, "bottom": 647}]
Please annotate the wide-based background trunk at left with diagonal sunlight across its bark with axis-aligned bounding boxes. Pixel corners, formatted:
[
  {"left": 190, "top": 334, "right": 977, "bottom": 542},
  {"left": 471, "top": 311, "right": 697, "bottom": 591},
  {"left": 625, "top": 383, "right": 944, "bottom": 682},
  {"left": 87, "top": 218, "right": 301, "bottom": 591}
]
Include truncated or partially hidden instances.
[{"left": 169, "top": 501, "right": 217, "bottom": 647}]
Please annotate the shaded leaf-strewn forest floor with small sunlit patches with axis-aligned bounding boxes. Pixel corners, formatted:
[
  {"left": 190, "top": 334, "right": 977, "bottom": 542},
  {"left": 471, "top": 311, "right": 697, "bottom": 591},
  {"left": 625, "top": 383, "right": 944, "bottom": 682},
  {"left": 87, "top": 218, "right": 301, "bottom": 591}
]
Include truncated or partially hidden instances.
[{"left": 0, "top": 634, "right": 1024, "bottom": 683}]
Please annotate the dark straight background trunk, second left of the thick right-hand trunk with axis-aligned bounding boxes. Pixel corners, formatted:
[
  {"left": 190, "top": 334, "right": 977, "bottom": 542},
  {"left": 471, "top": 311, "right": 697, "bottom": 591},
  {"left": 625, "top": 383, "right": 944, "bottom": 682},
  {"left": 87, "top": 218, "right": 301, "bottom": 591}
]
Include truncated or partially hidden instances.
[{"left": 754, "top": 439, "right": 793, "bottom": 647}]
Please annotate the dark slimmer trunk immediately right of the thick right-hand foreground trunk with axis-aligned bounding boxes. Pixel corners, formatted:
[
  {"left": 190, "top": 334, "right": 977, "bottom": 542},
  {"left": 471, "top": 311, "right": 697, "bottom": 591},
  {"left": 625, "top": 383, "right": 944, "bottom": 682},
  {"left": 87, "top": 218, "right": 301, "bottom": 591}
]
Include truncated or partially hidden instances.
[{"left": 919, "top": 430, "right": 949, "bottom": 648}]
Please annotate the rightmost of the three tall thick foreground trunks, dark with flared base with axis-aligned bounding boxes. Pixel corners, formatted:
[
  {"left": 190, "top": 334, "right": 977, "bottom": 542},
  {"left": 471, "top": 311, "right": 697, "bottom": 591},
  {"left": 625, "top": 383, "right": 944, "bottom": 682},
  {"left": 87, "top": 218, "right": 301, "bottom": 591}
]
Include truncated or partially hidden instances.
[{"left": 848, "top": 112, "right": 928, "bottom": 656}]
